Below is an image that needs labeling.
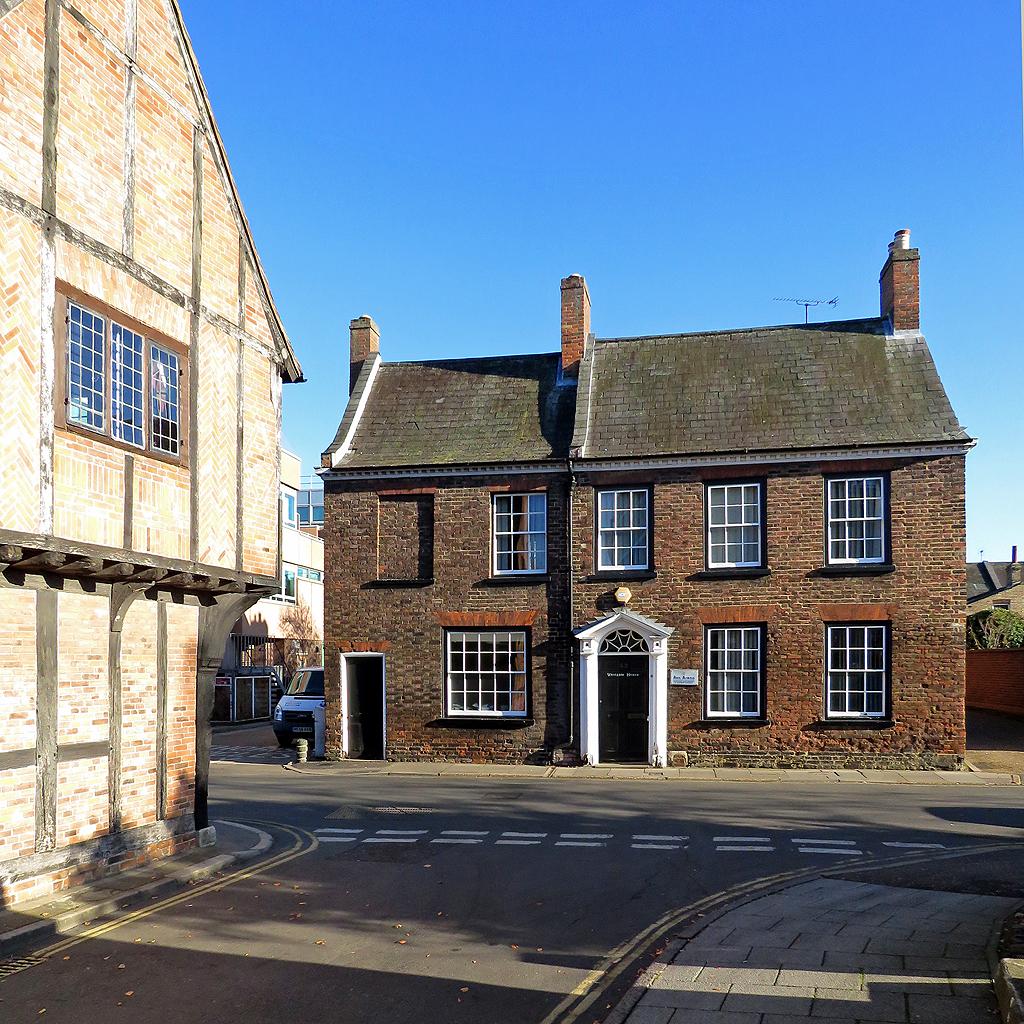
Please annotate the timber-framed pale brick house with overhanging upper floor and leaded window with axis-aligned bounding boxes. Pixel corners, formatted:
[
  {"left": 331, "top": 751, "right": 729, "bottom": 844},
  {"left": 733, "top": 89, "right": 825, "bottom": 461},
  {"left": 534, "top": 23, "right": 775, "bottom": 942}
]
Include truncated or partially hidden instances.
[{"left": 0, "top": 0, "right": 300, "bottom": 903}]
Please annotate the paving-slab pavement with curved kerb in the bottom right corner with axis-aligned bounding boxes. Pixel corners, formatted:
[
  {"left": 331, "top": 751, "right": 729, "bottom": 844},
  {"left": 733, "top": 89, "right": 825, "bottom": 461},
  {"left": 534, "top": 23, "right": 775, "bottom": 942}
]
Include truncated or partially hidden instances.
[{"left": 606, "top": 878, "right": 1020, "bottom": 1024}]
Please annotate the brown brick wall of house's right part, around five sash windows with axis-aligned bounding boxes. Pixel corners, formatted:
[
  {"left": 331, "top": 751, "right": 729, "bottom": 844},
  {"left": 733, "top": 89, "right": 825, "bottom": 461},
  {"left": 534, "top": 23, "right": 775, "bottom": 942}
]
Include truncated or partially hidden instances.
[{"left": 573, "top": 458, "right": 966, "bottom": 764}]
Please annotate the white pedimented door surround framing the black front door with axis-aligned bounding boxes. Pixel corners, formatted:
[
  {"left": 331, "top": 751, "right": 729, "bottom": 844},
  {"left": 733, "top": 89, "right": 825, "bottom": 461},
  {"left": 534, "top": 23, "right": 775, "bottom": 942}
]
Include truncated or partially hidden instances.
[{"left": 574, "top": 608, "right": 675, "bottom": 768}]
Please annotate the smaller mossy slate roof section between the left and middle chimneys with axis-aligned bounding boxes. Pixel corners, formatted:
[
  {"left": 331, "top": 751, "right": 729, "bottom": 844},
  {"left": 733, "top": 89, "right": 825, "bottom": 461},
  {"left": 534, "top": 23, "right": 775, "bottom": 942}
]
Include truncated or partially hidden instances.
[{"left": 326, "top": 352, "right": 577, "bottom": 469}]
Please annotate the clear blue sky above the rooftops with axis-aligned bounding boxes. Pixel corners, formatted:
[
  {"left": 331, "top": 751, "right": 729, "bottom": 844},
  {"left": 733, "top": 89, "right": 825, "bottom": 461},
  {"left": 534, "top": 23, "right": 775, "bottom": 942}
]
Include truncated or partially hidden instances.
[{"left": 180, "top": 0, "right": 1024, "bottom": 560}]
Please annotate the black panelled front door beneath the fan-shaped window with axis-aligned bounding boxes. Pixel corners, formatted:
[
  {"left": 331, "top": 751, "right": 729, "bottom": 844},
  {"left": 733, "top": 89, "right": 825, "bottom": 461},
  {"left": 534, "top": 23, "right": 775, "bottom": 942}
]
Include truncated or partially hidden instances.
[{"left": 597, "top": 654, "right": 650, "bottom": 763}]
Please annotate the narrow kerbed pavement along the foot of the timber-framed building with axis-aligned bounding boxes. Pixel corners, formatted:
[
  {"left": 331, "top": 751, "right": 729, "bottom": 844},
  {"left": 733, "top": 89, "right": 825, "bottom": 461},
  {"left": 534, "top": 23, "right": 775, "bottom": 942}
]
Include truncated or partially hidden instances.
[{"left": 0, "top": 821, "right": 273, "bottom": 962}]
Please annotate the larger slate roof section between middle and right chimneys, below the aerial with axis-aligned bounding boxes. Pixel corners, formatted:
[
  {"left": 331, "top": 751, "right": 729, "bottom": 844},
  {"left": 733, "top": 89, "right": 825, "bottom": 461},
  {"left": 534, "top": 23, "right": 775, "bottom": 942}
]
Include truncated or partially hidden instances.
[{"left": 572, "top": 318, "right": 970, "bottom": 459}]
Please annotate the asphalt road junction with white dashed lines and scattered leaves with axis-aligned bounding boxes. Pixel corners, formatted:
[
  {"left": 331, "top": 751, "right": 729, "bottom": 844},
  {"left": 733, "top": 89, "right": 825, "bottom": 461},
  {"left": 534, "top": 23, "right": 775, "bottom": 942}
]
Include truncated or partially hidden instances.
[{"left": 0, "top": 763, "right": 1024, "bottom": 1024}]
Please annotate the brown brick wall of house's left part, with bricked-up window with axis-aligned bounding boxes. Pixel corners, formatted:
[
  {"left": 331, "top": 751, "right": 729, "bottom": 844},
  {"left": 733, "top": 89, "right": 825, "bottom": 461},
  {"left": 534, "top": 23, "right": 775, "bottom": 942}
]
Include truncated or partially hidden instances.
[{"left": 325, "top": 477, "right": 569, "bottom": 762}]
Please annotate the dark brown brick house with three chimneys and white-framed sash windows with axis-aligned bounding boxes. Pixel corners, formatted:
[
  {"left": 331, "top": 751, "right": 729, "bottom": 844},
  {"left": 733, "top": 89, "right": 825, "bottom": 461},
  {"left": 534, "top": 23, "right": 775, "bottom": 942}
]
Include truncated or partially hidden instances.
[{"left": 322, "top": 231, "right": 973, "bottom": 767}]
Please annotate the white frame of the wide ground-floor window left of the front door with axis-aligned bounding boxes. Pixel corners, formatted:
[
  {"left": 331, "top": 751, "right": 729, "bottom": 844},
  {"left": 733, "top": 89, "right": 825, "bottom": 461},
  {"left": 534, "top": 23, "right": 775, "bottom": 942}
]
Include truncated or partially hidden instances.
[{"left": 444, "top": 630, "right": 529, "bottom": 718}]
